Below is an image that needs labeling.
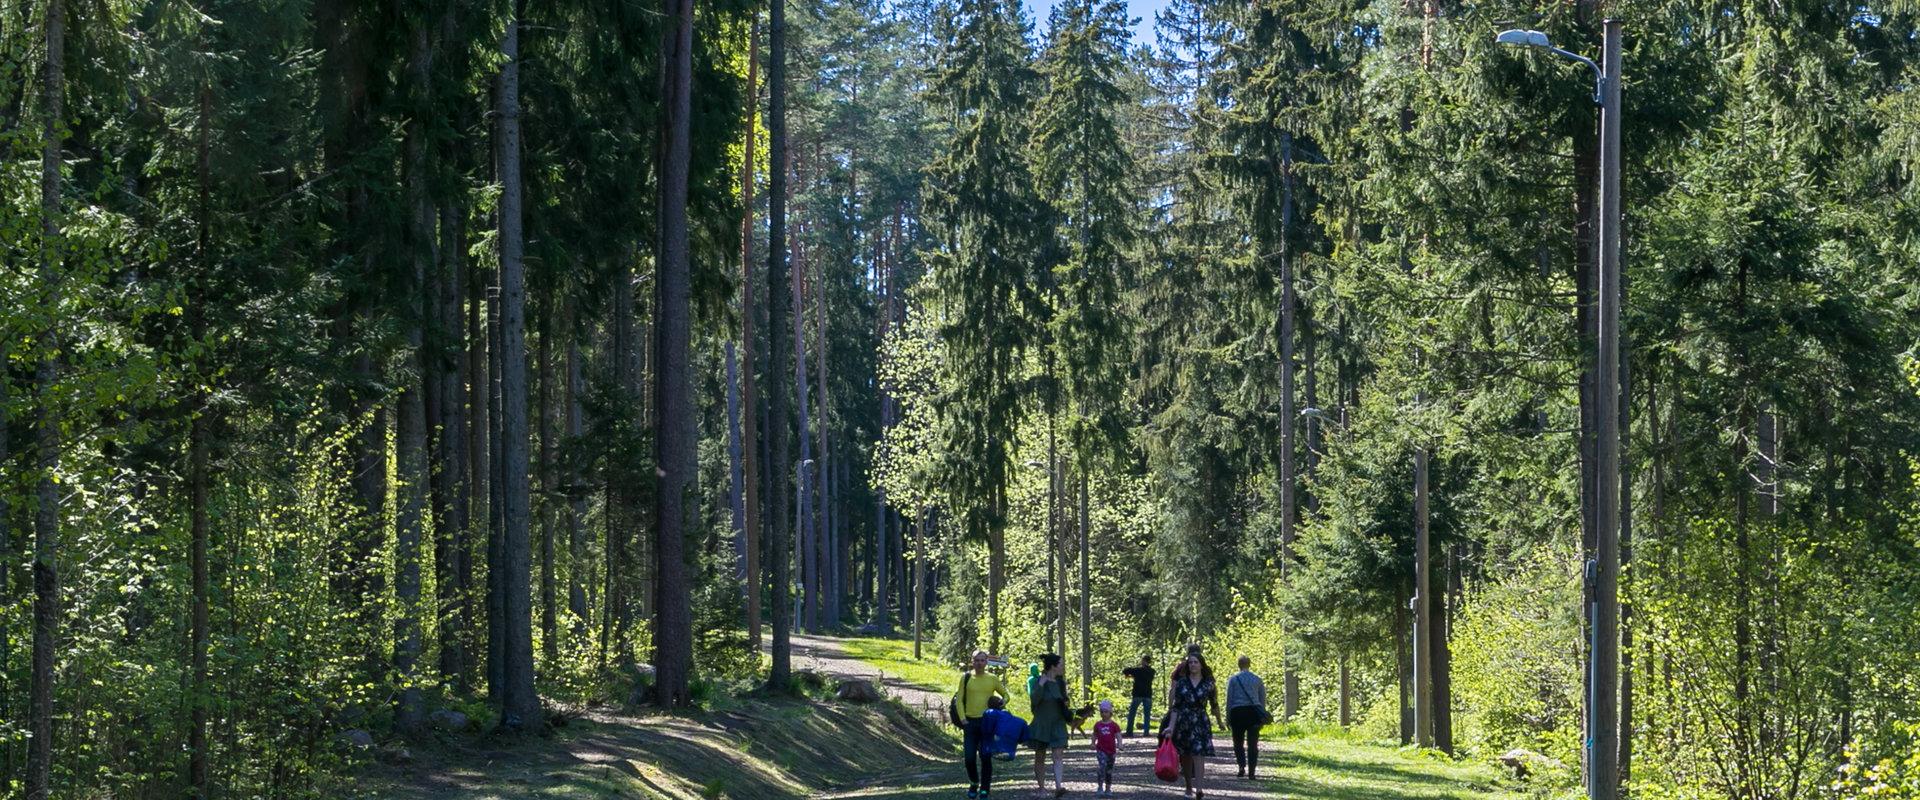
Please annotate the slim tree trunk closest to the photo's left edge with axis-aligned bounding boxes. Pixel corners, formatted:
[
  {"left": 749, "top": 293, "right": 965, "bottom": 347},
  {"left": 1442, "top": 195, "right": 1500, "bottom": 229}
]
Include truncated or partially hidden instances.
[{"left": 27, "top": 0, "right": 67, "bottom": 786}]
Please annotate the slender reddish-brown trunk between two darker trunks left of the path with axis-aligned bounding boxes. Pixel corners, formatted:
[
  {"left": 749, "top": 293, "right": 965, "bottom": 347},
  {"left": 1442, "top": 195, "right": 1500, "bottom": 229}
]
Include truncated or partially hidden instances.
[{"left": 739, "top": 13, "right": 766, "bottom": 652}]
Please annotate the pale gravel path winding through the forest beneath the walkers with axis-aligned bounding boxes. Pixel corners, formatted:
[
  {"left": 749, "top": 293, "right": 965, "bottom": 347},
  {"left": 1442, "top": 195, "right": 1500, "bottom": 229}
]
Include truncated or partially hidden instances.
[{"left": 793, "top": 635, "right": 1279, "bottom": 800}]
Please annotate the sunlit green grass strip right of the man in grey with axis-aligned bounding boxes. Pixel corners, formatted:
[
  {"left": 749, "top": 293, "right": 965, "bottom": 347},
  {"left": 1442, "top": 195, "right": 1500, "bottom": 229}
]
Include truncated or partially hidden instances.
[{"left": 1267, "top": 729, "right": 1519, "bottom": 800}]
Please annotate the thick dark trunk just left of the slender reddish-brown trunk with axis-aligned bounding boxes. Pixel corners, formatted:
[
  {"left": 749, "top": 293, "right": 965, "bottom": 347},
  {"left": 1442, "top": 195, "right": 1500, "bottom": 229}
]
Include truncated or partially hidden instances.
[{"left": 653, "top": 0, "right": 699, "bottom": 708}]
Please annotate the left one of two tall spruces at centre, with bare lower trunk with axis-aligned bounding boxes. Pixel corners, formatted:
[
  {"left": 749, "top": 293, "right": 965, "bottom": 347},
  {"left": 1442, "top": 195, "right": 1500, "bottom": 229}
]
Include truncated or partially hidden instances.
[{"left": 925, "top": 0, "right": 1050, "bottom": 650}]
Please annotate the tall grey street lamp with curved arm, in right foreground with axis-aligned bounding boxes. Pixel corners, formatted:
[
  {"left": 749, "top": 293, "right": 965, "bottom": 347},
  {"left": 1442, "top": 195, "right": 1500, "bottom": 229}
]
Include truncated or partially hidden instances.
[{"left": 1494, "top": 19, "right": 1626, "bottom": 800}]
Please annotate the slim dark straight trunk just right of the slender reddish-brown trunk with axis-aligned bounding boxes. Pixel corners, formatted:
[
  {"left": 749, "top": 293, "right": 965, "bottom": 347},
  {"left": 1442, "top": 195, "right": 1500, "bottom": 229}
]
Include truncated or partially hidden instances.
[{"left": 766, "top": 0, "right": 793, "bottom": 693}]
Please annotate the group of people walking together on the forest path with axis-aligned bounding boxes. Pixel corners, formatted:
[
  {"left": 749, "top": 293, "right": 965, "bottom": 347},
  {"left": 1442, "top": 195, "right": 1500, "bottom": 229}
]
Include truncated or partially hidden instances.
[{"left": 948, "top": 645, "right": 1273, "bottom": 800}]
